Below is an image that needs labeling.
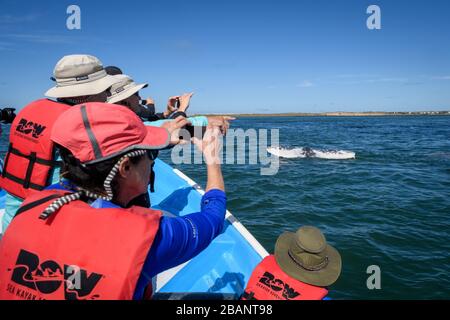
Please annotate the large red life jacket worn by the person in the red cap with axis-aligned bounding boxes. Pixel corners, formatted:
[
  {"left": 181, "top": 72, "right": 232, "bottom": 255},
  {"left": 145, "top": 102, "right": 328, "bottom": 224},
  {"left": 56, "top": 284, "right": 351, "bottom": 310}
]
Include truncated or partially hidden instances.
[{"left": 0, "top": 190, "right": 161, "bottom": 300}]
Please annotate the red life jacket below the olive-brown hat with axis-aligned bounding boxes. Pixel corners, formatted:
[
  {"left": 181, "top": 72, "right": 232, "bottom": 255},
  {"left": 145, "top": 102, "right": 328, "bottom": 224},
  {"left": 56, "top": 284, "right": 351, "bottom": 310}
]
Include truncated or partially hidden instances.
[{"left": 242, "top": 255, "right": 328, "bottom": 300}]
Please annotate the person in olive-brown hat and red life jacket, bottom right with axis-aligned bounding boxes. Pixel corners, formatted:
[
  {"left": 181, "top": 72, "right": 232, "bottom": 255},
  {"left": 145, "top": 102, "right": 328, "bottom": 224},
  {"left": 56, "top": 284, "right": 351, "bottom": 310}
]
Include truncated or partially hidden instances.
[{"left": 242, "top": 226, "right": 342, "bottom": 300}]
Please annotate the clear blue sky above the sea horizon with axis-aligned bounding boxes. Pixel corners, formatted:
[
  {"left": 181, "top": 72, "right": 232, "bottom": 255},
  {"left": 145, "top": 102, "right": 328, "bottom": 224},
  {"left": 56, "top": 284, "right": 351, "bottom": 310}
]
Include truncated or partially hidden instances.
[{"left": 0, "top": 0, "right": 450, "bottom": 113}]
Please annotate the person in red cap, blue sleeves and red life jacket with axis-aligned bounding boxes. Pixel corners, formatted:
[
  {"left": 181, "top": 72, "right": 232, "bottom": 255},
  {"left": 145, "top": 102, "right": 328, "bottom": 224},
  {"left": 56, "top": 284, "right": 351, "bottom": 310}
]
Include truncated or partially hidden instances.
[{"left": 0, "top": 103, "right": 226, "bottom": 300}]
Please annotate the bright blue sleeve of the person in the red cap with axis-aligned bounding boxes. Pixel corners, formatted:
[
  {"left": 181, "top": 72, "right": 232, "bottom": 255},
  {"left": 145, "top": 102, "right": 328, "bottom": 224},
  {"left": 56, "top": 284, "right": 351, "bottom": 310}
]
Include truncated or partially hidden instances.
[{"left": 135, "top": 189, "right": 226, "bottom": 296}]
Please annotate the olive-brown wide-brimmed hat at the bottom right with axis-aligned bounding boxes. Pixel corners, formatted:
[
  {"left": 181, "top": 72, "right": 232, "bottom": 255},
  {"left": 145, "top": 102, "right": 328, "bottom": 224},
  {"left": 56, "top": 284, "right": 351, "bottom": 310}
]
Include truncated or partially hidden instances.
[{"left": 275, "top": 226, "right": 342, "bottom": 287}]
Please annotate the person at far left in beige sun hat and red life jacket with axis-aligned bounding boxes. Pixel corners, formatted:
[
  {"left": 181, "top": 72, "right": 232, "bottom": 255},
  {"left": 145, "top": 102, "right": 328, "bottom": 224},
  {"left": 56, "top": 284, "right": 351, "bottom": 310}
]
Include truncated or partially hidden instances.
[{"left": 0, "top": 55, "right": 126, "bottom": 231}]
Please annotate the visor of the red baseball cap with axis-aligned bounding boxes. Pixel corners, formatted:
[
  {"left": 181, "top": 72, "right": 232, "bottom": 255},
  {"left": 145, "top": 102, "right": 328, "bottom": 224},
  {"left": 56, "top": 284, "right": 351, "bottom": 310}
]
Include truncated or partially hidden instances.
[{"left": 84, "top": 126, "right": 170, "bottom": 165}]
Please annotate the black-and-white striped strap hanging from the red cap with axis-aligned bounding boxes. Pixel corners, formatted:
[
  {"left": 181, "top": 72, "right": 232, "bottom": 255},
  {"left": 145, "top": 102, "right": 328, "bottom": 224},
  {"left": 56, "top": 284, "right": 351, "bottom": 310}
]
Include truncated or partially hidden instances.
[{"left": 39, "top": 150, "right": 147, "bottom": 220}]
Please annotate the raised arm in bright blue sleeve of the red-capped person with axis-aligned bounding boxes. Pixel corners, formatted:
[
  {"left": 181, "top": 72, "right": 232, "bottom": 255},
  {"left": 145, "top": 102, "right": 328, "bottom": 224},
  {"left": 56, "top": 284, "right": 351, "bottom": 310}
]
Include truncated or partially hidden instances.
[{"left": 135, "top": 127, "right": 226, "bottom": 297}]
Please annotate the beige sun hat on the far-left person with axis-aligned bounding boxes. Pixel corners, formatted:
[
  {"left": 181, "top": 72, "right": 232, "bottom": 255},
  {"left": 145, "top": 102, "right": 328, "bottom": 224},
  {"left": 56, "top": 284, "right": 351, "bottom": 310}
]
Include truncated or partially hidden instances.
[{"left": 45, "top": 54, "right": 121, "bottom": 98}]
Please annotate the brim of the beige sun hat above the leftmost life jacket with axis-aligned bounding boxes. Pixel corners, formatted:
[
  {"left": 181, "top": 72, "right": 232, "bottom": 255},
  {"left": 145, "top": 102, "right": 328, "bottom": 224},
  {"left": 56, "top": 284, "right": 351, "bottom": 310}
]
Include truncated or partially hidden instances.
[{"left": 45, "top": 75, "right": 118, "bottom": 98}]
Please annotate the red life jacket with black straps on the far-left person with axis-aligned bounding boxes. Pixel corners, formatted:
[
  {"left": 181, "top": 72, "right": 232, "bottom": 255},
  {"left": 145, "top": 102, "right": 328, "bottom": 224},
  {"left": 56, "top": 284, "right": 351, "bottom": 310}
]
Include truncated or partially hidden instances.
[{"left": 0, "top": 99, "right": 70, "bottom": 199}]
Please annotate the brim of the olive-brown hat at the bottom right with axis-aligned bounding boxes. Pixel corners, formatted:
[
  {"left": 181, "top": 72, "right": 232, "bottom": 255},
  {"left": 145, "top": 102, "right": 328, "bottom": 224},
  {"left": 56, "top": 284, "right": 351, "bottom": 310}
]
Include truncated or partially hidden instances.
[{"left": 275, "top": 232, "right": 342, "bottom": 287}]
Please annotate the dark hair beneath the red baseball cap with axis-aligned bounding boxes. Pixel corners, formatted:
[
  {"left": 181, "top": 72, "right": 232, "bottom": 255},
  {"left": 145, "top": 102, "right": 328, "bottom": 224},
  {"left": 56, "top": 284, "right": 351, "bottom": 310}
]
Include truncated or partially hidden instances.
[{"left": 56, "top": 145, "right": 144, "bottom": 196}]
